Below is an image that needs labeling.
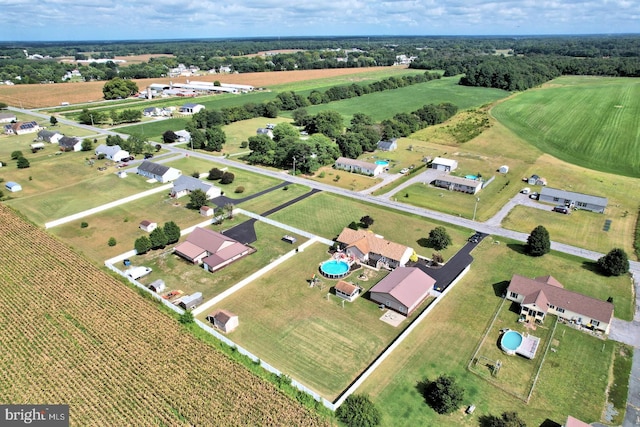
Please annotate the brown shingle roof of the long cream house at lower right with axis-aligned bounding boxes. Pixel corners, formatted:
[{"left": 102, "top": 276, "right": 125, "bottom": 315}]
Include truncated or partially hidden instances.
[{"left": 507, "top": 274, "right": 613, "bottom": 323}]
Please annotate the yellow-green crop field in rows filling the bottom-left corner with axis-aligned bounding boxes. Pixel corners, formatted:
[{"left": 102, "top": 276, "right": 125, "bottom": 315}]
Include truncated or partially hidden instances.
[{"left": 0, "top": 206, "right": 328, "bottom": 426}]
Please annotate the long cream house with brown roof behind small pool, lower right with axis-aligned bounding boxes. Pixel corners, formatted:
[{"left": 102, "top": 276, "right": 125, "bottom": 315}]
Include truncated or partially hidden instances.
[{"left": 507, "top": 274, "right": 613, "bottom": 334}]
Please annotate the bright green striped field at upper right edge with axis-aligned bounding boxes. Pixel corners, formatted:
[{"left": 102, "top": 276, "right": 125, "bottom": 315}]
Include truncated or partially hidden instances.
[{"left": 492, "top": 77, "right": 640, "bottom": 177}]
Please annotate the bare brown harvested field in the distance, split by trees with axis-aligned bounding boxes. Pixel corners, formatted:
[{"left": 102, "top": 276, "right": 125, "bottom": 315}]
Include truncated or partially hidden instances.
[{"left": 0, "top": 67, "right": 400, "bottom": 108}]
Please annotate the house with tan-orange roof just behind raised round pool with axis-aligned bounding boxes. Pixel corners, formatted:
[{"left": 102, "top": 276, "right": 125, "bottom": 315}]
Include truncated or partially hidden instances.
[{"left": 336, "top": 228, "right": 413, "bottom": 268}]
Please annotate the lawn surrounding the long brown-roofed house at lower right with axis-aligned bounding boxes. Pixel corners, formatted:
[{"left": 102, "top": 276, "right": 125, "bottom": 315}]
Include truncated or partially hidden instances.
[{"left": 359, "top": 238, "right": 632, "bottom": 426}]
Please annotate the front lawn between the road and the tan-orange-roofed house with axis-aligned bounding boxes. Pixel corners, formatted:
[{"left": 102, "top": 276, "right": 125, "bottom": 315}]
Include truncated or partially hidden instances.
[{"left": 269, "top": 193, "right": 469, "bottom": 260}]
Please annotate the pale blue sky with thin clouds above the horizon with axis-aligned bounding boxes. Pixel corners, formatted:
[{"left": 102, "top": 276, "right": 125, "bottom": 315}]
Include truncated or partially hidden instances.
[{"left": 0, "top": 0, "right": 640, "bottom": 41}]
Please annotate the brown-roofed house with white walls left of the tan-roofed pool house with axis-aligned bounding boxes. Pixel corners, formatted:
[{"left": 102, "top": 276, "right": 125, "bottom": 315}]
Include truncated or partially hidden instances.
[{"left": 174, "top": 227, "right": 253, "bottom": 272}]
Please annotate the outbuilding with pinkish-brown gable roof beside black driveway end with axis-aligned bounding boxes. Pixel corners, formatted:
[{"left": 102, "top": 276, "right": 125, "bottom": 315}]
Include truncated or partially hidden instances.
[{"left": 370, "top": 267, "right": 436, "bottom": 316}]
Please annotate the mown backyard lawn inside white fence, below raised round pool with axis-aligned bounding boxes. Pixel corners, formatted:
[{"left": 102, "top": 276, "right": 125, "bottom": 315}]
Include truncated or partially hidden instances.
[{"left": 195, "top": 244, "right": 426, "bottom": 400}]
